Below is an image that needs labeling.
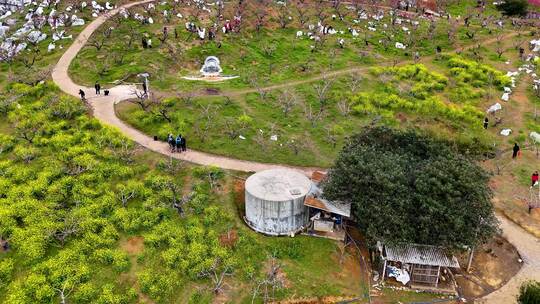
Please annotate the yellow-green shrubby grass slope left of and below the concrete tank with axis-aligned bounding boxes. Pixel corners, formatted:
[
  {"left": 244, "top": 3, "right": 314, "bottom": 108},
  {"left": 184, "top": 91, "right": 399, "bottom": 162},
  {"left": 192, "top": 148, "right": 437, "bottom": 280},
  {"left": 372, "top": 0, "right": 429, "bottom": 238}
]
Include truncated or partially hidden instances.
[{"left": 0, "top": 84, "right": 372, "bottom": 303}]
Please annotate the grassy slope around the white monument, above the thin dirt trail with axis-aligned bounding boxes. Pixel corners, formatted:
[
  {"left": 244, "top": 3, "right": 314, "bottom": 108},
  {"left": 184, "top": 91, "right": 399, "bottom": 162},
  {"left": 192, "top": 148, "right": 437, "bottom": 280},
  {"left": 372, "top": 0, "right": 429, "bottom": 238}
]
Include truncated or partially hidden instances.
[{"left": 70, "top": 1, "right": 510, "bottom": 92}]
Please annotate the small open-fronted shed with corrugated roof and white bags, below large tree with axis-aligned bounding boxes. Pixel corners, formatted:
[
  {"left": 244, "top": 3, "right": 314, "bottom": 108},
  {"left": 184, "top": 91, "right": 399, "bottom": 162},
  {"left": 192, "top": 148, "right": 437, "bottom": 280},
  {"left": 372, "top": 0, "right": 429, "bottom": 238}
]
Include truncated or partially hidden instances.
[{"left": 378, "top": 243, "right": 459, "bottom": 288}]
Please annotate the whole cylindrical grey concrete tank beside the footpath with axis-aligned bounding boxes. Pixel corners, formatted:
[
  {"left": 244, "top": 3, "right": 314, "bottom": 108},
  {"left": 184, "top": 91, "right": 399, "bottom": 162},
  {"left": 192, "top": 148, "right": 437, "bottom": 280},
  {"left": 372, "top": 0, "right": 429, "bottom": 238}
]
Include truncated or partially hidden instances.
[{"left": 246, "top": 169, "right": 311, "bottom": 235}]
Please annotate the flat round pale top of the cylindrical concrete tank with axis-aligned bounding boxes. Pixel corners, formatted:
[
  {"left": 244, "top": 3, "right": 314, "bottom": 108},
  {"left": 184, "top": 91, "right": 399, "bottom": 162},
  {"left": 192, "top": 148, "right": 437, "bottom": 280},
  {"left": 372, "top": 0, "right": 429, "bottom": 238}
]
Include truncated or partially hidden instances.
[{"left": 246, "top": 169, "right": 311, "bottom": 201}]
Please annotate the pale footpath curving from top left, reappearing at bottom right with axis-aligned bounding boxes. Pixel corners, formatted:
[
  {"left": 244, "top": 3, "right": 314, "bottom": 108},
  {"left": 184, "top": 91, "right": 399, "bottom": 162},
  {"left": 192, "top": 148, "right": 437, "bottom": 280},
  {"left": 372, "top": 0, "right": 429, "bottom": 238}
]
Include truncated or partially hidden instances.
[{"left": 52, "top": 0, "right": 540, "bottom": 304}]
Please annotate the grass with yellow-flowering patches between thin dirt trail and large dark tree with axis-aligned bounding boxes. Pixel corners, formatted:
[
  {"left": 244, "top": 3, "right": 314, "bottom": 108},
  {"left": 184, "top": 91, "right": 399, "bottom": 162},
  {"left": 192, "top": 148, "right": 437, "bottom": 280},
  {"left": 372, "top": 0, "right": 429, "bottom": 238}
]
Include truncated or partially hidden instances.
[{"left": 116, "top": 55, "right": 499, "bottom": 167}]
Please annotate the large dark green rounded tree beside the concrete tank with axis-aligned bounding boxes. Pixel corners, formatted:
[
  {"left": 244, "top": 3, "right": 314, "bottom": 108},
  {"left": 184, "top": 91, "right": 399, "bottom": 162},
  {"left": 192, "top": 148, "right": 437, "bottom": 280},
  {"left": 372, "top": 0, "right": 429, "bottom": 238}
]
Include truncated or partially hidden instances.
[{"left": 323, "top": 127, "right": 497, "bottom": 247}]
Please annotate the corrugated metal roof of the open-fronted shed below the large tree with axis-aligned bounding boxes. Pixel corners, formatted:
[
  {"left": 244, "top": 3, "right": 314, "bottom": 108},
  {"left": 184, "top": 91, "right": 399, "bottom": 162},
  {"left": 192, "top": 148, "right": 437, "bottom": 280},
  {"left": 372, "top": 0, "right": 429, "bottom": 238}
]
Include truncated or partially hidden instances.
[{"left": 384, "top": 244, "right": 459, "bottom": 268}]
